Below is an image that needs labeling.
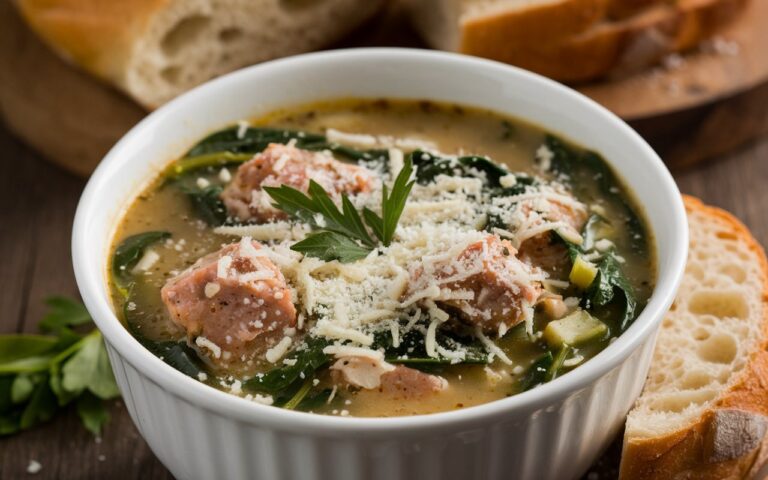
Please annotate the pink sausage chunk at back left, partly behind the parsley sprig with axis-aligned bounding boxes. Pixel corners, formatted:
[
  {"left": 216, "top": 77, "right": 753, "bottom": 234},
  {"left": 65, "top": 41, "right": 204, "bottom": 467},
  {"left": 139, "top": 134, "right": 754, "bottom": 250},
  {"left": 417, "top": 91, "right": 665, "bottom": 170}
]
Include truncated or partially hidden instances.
[{"left": 221, "top": 143, "right": 374, "bottom": 222}]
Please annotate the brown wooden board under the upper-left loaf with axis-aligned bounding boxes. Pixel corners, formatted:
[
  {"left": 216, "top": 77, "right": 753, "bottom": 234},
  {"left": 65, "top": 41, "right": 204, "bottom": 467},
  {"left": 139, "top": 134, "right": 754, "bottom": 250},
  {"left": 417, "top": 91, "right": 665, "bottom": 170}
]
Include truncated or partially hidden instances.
[{"left": 0, "top": 2, "right": 146, "bottom": 176}]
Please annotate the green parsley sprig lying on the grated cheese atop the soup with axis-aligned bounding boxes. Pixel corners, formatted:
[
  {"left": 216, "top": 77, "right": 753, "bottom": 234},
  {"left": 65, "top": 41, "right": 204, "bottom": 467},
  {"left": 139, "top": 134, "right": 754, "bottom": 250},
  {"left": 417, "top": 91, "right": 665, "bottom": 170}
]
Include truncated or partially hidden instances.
[{"left": 264, "top": 157, "right": 415, "bottom": 263}]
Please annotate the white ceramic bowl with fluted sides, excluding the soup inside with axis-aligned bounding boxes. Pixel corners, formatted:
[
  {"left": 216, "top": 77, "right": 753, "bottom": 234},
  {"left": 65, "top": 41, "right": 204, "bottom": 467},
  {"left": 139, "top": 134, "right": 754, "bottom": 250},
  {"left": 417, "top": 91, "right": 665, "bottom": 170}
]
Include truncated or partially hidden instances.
[{"left": 72, "top": 49, "right": 688, "bottom": 480}]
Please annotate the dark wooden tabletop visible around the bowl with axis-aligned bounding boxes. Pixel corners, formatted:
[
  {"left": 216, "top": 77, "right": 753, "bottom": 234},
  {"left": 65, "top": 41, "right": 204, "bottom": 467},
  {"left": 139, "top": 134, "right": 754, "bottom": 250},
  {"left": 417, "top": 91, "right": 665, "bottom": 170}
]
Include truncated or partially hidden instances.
[{"left": 0, "top": 115, "right": 768, "bottom": 480}]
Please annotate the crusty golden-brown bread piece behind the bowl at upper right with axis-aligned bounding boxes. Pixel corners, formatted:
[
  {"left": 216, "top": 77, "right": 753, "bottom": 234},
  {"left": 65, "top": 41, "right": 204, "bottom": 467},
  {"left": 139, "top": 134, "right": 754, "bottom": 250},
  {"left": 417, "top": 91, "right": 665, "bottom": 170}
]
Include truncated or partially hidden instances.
[{"left": 407, "top": 0, "right": 749, "bottom": 82}]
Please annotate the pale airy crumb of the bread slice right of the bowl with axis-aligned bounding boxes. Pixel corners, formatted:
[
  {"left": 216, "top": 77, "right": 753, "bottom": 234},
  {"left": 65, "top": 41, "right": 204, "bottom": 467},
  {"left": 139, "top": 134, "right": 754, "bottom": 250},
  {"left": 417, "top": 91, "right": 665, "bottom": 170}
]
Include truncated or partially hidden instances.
[{"left": 627, "top": 195, "right": 766, "bottom": 437}]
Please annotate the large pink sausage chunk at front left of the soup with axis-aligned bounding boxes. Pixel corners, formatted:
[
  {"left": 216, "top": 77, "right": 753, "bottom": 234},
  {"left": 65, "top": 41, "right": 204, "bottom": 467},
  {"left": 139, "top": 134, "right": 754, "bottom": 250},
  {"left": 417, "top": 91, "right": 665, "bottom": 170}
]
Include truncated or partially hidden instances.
[{"left": 161, "top": 237, "right": 296, "bottom": 363}]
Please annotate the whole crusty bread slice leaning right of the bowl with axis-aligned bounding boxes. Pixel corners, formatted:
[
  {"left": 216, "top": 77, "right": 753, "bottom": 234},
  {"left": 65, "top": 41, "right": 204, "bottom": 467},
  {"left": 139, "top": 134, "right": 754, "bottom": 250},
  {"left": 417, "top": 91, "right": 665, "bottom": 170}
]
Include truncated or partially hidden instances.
[{"left": 621, "top": 197, "right": 768, "bottom": 480}]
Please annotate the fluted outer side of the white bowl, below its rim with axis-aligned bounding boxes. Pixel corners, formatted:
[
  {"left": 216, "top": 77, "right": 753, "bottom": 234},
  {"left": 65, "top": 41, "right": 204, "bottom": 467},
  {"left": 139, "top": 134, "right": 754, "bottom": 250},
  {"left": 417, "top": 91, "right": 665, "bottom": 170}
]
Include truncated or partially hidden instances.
[{"left": 103, "top": 337, "right": 653, "bottom": 480}]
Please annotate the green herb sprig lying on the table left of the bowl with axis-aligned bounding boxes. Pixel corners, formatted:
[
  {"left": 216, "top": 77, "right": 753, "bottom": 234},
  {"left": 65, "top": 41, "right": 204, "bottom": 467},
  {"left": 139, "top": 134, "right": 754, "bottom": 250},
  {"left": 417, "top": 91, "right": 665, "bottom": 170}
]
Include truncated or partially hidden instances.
[{"left": 0, "top": 297, "right": 120, "bottom": 435}]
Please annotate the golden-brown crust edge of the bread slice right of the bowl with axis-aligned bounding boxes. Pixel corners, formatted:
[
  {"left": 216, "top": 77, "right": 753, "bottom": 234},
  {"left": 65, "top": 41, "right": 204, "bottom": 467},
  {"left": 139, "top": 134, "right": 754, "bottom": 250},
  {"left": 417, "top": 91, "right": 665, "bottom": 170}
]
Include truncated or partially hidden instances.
[{"left": 620, "top": 196, "right": 768, "bottom": 480}]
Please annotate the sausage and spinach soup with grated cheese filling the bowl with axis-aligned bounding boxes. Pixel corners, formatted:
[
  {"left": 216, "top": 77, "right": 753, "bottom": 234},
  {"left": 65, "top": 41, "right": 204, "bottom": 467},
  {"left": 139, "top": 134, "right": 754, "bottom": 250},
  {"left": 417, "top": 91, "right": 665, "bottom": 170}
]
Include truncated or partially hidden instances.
[{"left": 110, "top": 100, "right": 655, "bottom": 417}]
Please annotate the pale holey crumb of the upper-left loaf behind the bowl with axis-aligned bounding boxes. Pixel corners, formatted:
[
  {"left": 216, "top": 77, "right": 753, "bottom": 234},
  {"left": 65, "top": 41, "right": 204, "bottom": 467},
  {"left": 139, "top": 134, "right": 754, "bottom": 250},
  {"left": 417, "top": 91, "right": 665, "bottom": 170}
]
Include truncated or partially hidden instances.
[{"left": 129, "top": 0, "right": 382, "bottom": 106}]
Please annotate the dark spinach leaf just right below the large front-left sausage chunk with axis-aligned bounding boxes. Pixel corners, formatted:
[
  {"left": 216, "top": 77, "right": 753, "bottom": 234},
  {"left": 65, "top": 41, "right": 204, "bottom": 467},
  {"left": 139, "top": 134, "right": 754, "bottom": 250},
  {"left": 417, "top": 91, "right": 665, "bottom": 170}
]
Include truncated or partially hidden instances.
[{"left": 243, "top": 336, "right": 330, "bottom": 395}]
